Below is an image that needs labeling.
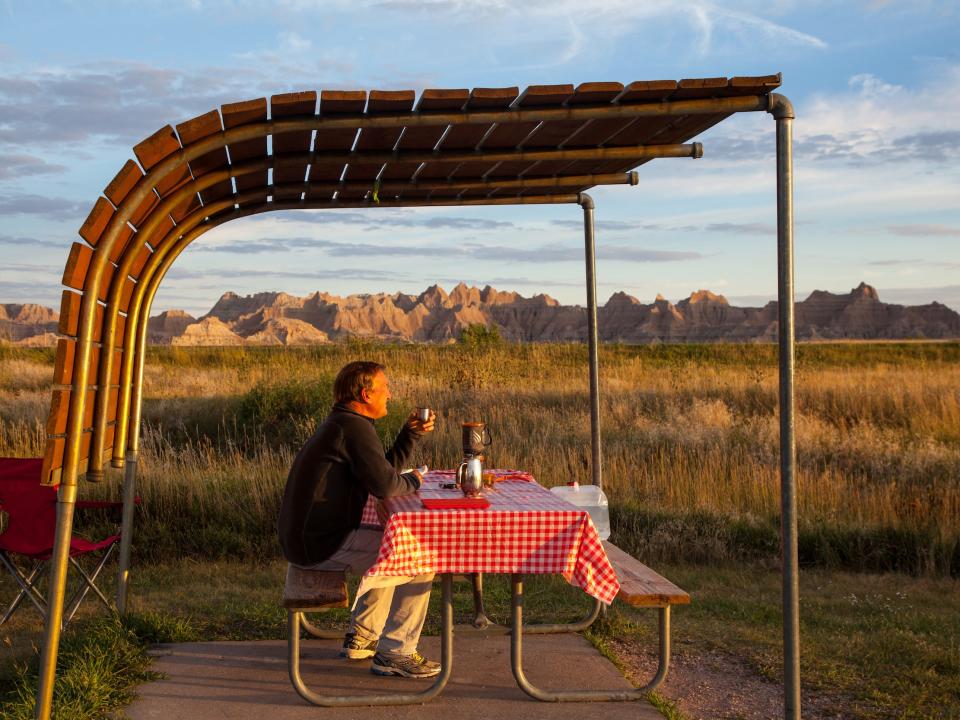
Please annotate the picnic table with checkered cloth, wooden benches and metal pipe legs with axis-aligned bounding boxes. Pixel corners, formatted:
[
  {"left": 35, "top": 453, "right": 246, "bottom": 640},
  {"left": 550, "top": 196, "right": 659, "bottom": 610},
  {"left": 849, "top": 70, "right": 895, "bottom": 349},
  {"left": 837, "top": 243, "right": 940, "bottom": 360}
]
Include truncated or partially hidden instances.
[{"left": 285, "top": 470, "right": 689, "bottom": 706}]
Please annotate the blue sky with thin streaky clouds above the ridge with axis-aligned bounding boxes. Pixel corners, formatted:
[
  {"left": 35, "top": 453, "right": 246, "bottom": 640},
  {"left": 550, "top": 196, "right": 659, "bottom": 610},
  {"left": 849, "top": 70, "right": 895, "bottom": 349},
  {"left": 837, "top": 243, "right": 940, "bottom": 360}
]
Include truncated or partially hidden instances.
[{"left": 0, "top": 0, "right": 960, "bottom": 315}]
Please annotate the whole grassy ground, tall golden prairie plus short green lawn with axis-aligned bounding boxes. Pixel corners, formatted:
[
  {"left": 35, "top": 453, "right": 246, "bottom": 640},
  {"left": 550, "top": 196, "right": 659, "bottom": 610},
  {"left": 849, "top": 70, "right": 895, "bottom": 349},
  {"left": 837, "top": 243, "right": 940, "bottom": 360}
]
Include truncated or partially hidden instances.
[{"left": 0, "top": 337, "right": 960, "bottom": 720}]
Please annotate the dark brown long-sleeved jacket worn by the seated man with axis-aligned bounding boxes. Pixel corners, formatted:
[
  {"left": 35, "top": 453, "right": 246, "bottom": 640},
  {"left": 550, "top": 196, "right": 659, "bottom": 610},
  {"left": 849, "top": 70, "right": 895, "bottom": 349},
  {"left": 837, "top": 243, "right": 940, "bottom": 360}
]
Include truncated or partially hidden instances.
[{"left": 278, "top": 405, "right": 420, "bottom": 565}]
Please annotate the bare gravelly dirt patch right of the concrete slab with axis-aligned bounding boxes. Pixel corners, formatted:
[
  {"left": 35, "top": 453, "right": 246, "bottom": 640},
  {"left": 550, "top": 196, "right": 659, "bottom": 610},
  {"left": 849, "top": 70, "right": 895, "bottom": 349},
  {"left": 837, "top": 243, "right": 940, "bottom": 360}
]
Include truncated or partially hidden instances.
[{"left": 610, "top": 641, "right": 862, "bottom": 720}]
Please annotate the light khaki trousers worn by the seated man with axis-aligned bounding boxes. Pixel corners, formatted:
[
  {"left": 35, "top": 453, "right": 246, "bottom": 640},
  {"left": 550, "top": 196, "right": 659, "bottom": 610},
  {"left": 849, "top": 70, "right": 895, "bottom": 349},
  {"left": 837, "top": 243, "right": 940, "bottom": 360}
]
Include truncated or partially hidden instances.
[{"left": 306, "top": 527, "right": 433, "bottom": 655}]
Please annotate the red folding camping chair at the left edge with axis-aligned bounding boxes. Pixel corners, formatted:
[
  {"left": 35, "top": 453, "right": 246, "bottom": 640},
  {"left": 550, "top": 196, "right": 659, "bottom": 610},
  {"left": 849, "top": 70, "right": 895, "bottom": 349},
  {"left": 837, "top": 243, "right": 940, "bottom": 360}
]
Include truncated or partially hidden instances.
[{"left": 0, "top": 458, "right": 129, "bottom": 627}]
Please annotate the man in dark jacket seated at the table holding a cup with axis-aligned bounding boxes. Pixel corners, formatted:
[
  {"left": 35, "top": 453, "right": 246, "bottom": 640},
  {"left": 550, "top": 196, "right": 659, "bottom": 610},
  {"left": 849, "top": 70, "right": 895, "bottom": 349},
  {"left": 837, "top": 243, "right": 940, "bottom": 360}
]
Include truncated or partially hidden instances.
[{"left": 278, "top": 361, "right": 440, "bottom": 678}]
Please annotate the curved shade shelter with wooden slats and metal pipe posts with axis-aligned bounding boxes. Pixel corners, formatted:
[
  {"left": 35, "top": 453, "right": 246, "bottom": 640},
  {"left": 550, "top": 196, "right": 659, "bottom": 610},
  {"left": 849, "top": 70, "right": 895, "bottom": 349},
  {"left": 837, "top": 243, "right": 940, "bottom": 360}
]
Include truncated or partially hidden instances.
[{"left": 30, "top": 75, "right": 799, "bottom": 718}]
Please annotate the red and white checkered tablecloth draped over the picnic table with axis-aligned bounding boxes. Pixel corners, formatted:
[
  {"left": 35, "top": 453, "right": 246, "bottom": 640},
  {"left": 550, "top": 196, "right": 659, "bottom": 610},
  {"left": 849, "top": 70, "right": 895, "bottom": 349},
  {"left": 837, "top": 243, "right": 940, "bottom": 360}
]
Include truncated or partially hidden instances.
[{"left": 356, "top": 470, "right": 620, "bottom": 604}]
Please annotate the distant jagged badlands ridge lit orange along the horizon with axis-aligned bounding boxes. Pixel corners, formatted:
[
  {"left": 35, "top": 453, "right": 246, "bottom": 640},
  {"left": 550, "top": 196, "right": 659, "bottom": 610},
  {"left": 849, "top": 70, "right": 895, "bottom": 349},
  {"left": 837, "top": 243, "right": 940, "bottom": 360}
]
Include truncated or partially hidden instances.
[{"left": 0, "top": 283, "right": 960, "bottom": 345}]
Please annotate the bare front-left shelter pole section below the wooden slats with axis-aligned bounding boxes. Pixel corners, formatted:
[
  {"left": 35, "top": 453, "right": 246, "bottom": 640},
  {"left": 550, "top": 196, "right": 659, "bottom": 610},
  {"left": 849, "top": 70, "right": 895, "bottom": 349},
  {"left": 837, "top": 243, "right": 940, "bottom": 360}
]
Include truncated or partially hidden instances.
[{"left": 34, "top": 475, "right": 77, "bottom": 720}]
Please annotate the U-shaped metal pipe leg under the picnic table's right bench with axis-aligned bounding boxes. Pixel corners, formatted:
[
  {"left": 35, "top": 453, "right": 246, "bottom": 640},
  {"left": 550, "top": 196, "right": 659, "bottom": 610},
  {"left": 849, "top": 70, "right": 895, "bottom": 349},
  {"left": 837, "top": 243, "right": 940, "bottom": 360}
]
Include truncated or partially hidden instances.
[{"left": 510, "top": 575, "right": 670, "bottom": 702}]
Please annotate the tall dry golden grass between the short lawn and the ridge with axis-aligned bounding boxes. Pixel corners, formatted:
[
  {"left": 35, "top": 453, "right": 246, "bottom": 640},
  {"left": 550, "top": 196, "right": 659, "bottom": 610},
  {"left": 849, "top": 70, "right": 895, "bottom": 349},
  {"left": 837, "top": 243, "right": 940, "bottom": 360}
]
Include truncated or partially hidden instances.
[{"left": 0, "top": 340, "right": 960, "bottom": 573}]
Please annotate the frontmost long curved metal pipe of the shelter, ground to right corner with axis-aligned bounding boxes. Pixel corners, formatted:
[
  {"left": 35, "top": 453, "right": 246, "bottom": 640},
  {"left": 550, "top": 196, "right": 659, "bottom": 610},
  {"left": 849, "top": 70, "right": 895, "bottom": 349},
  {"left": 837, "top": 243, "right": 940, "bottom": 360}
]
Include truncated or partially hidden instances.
[{"left": 35, "top": 95, "right": 769, "bottom": 720}]
